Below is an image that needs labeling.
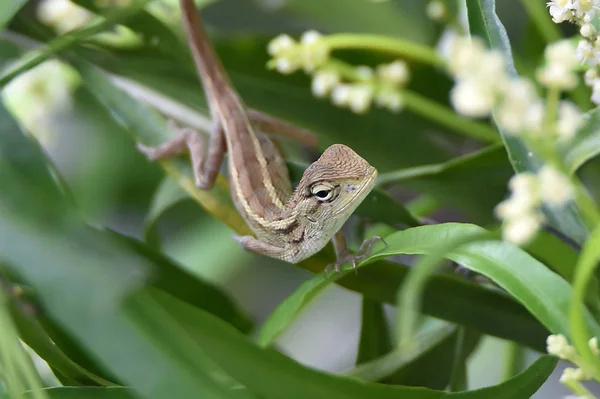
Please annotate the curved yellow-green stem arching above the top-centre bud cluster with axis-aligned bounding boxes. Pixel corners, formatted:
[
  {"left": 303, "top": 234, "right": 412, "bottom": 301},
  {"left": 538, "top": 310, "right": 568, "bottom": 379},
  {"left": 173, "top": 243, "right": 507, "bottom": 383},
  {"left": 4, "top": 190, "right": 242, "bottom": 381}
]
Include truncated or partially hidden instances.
[{"left": 323, "top": 33, "right": 446, "bottom": 67}]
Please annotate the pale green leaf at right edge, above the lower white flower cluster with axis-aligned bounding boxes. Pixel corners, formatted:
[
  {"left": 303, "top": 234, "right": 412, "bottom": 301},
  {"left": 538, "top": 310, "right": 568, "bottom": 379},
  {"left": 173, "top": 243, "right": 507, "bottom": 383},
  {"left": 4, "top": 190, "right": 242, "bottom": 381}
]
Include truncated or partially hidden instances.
[{"left": 563, "top": 109, "right": 600, "bottom": 173}]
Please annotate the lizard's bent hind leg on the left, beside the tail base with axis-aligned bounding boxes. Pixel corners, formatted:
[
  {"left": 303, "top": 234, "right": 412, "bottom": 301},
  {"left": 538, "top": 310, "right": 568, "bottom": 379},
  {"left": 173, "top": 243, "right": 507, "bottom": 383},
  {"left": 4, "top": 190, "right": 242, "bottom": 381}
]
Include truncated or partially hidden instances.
[{"left": 137, "top": 121, "right": 226, "bottom": 190}]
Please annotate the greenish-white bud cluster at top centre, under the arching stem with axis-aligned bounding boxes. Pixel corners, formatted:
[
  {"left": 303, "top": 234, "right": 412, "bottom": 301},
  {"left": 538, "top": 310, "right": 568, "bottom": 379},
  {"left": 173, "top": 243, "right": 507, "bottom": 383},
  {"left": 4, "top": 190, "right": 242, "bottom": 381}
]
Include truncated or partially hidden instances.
[{"left": 268, "top": 31, "right": 410, "bottom": 113}]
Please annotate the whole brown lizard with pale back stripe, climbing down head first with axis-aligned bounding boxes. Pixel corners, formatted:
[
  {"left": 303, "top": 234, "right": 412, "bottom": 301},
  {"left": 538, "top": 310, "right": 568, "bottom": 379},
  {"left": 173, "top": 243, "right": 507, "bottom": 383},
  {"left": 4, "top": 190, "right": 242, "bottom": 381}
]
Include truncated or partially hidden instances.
[{"left": 138, "top": 0, "right": 383, "bottom": 273}]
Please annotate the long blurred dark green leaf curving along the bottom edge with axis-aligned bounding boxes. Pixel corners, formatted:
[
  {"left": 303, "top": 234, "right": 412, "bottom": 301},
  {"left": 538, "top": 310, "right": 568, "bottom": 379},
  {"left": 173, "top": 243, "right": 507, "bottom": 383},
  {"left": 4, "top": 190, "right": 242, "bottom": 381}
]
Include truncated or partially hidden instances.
[{"left": 151, "top": 290, "right": 556, "bottom": 399}]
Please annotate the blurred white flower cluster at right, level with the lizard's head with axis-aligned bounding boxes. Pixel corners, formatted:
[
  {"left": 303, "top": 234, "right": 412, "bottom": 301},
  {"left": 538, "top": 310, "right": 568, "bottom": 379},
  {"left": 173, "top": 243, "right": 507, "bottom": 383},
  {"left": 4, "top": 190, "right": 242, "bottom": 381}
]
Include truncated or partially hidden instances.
[{"left": 495, "top": 165, "right": 574, "bottom": 245}]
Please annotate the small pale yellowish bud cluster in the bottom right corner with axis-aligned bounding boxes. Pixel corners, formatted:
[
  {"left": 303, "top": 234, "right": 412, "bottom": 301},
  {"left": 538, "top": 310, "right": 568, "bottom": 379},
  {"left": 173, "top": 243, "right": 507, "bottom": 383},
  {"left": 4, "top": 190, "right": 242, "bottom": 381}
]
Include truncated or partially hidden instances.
[{"left": 546, "top": 334, "right": 600, "bottom": 397}]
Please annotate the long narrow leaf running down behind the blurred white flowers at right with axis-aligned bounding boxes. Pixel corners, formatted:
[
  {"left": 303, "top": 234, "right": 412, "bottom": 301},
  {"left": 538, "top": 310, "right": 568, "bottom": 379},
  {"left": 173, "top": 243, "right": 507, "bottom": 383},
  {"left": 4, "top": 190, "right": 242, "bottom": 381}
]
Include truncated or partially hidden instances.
[{"left": 466, "top": 0, "right": 588, "bottom": 244}]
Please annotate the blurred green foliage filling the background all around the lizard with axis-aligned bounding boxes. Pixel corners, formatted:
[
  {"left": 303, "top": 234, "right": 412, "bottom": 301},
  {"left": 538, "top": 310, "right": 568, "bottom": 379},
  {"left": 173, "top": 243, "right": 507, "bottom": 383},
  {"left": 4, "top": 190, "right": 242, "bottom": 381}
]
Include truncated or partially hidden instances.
[{"left": 0, "top": 0, "right": 600, "bottom": 399}]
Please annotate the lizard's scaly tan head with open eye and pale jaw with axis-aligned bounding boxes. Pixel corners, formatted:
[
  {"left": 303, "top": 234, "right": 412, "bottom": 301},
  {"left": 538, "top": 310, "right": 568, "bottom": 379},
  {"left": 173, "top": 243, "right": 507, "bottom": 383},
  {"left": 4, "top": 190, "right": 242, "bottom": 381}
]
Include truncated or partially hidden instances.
[{"left": 291, "top": 144, "right": 377, "bottom": 238}]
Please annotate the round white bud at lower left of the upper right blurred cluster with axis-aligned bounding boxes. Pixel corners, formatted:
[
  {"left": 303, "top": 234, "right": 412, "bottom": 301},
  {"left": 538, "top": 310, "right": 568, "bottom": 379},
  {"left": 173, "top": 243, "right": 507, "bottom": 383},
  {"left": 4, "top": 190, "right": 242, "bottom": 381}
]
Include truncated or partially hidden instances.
[{"left": 450, "top": 79, "right": 494, "bottom": 118}]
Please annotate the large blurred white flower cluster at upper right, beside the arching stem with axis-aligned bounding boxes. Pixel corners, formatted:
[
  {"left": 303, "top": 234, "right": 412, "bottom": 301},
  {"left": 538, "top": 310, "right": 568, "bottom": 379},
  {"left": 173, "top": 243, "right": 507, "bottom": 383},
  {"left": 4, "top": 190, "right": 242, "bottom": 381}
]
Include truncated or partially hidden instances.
[{"left": 441, "top": 36, "right": 583, "bottom": 141}]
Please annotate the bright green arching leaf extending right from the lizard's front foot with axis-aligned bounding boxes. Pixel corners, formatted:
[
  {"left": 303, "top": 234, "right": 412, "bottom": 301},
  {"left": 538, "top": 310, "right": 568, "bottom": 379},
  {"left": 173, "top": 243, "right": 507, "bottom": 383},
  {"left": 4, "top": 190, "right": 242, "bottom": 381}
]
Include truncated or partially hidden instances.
[{"left": 367, "top": 223, "right": 600, "bottom": 342}]
